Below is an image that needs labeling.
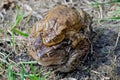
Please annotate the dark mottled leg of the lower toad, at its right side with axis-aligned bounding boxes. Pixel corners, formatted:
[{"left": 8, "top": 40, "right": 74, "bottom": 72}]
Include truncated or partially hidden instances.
[{"left": 58, "top": 39, "right": 90, "bottom": 72}]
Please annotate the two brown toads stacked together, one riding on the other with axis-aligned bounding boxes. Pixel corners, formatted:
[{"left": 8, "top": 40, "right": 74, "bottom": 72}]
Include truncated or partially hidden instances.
[{"left": 28, "top": 5, "right": 92, "bottom": 72}]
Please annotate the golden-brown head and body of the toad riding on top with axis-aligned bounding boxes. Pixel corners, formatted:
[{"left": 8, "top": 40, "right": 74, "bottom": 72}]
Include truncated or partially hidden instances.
[{"left": 32, "top": 5, "right": 89, "bottom": 47}]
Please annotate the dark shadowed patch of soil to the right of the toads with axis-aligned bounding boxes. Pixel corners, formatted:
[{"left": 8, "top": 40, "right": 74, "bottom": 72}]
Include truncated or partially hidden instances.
[{"left": 51, "top": 28, "right": 120, "bottom": 80}]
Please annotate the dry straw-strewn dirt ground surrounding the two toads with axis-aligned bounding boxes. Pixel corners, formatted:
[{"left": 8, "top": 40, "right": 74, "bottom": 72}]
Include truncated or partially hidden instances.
[{"left": 0, "top": 0, "right": 120, "bottom": 80}]
